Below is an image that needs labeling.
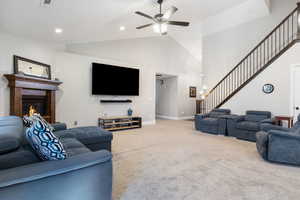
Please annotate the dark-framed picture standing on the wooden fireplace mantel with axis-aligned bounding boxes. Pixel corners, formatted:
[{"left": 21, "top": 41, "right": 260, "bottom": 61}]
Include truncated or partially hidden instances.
[{"left": 14, "top": 55, "right": 51, "bottom": 80}]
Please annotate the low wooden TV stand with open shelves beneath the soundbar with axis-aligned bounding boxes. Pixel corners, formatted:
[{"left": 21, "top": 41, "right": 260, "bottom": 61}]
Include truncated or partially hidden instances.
[{"left": 98, "top": 116, "right": 142, "bottom": 131}]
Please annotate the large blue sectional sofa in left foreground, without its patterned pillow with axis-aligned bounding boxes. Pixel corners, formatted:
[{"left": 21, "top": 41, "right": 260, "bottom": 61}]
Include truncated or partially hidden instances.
[{"left": 0, "top": 116, "right": 112, "bottom": 200}]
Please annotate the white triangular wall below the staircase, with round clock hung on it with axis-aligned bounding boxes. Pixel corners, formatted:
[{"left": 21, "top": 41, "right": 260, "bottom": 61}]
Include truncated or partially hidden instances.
[{"left": 222, "top": 44, "right": 300, "bottom": 115}]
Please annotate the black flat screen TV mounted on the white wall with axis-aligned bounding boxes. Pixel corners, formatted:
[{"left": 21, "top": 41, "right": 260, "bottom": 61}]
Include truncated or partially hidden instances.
[{"left": 92, "top": 63, "right": 140, "bottom": 96}]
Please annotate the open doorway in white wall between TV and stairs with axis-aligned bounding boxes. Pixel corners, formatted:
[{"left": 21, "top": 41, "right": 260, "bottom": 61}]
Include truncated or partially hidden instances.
[{"left": 155, "top": 74, "right": 178, "bottom": 120}]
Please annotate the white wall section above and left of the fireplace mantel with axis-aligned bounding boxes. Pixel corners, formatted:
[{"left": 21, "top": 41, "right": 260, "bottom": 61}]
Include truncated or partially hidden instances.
[{"left": 0, "top": 32, "right": 63, "bottom": 116}]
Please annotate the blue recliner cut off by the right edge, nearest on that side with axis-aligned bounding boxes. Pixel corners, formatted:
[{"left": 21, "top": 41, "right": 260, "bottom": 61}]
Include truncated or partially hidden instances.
[{"left": 256, "top": 115, "right": 300, "bottom": 165}]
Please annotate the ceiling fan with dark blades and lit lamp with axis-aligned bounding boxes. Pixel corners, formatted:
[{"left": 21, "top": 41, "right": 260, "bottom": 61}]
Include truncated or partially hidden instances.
[{"left": 135, "top": 0, "right": 190, "bottom": 35}]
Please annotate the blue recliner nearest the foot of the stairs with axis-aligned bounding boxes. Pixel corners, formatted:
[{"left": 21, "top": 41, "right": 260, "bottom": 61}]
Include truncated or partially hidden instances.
[{"left": 195, "top": 109, "right": 231, "bottom": 135}]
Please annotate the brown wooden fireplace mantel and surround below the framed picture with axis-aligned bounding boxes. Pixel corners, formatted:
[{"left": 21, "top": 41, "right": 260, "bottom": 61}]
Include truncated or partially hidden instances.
[{"left": 4, "top": 74, "right": 62, "bottom": 123}]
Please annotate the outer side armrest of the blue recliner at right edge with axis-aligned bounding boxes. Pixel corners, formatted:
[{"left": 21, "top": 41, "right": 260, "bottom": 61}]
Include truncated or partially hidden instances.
[{"left": 268, "top": 130, "right": 300, "bottom": 165}]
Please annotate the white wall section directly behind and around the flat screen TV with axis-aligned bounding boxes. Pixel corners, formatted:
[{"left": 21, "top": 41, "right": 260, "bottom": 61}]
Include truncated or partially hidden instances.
[{"left": 55, "top": 52, "right": 155, "bottom": 127}]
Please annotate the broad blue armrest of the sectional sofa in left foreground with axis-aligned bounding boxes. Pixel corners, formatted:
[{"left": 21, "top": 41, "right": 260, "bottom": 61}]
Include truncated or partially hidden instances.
[{"left": 0, "top": 151, "right": 112, "bottom": 200}]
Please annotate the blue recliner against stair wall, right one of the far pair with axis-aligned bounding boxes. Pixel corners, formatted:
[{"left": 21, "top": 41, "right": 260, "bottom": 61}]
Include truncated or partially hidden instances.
[{"left": 227, "top": 111, "right": 273, "bottom": 142}]
